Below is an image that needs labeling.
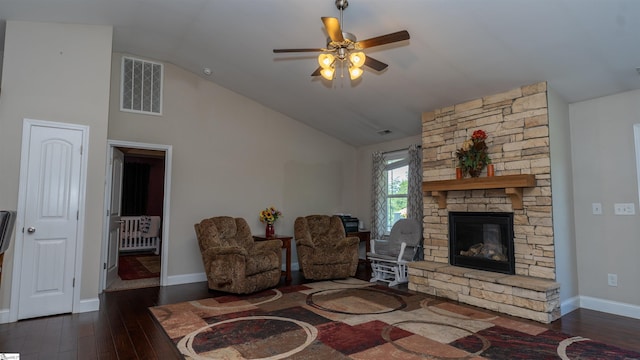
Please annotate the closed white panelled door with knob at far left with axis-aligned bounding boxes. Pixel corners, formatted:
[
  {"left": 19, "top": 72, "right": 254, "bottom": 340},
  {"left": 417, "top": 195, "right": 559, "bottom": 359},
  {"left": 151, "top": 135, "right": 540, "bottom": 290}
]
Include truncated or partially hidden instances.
[{"left": 18, "top": 124, "right": 83, "bottom": 319}]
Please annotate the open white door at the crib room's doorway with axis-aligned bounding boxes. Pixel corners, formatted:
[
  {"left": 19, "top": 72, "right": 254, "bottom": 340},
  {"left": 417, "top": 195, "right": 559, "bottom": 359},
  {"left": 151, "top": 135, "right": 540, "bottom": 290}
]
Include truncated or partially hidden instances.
[{"left": 106, "top": 148, "right": 124, "bottom": 288}]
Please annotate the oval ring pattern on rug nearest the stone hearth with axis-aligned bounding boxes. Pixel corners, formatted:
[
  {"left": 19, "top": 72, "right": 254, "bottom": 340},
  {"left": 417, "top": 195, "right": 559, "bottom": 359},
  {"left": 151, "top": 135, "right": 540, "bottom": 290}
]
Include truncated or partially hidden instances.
[{"left": 307, "top": 287, "right": 407, "bottom": 315}]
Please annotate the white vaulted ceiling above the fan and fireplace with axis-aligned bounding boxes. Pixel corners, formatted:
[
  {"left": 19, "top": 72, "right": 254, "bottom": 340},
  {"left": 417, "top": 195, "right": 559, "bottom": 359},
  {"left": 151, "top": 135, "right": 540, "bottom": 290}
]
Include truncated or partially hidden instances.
[{"left": 0, "top": 0, "right": 640, "bottom": 146}]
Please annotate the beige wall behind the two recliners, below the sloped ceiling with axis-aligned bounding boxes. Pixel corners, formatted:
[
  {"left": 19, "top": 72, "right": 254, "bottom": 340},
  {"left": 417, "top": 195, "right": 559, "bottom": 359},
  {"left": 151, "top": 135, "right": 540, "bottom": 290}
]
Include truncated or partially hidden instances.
[{"left": 109, "top": 54, "right": 357, "bottom": 276}]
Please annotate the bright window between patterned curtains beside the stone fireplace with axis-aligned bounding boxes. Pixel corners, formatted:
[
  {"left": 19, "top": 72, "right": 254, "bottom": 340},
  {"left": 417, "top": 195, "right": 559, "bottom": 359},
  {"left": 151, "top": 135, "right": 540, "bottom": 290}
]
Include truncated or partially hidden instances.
[{"left": 383, "top": 151, "right": 409, "bottom": 235}]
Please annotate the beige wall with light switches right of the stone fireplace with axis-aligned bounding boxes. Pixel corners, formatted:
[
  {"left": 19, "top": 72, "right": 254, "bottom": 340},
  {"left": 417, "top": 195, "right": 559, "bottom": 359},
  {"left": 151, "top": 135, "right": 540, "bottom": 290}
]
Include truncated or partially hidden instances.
[{"left": 569, "top": 91, "right": 640, "bottom": 310}]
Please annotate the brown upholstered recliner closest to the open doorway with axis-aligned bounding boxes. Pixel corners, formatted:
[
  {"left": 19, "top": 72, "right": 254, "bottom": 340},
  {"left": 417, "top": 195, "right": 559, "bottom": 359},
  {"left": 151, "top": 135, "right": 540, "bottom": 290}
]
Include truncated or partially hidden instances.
[{"left": 195, "top": 216, "right": 282, "bottom": 294}]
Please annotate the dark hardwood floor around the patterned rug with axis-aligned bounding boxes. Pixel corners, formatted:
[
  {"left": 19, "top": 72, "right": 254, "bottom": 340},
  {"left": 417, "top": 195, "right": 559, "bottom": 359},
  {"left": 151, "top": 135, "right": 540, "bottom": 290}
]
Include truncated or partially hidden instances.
[{"left": 0, "top": 266, "right": 640, "bottom": 360}]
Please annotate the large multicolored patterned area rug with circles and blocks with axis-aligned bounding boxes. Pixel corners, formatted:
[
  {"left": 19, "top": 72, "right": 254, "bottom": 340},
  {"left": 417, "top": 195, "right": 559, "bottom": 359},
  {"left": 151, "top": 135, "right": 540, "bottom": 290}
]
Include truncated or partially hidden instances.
[{"left": 150, "top": 279, "right": 640, "bottom": 360}]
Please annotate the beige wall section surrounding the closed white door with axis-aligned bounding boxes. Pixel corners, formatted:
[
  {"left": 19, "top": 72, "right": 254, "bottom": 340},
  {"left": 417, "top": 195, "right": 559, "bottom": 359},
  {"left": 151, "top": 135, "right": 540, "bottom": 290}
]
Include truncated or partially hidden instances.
[{"left": 0, "top": 21, "right": 112, "bottom": 310}]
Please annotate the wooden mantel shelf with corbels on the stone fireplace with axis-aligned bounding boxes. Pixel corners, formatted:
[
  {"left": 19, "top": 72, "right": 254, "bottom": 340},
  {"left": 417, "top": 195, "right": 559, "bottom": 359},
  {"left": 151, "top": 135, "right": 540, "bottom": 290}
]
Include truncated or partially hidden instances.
[{"left": 422, "top": 174, "right": 536, "bottom": 210}]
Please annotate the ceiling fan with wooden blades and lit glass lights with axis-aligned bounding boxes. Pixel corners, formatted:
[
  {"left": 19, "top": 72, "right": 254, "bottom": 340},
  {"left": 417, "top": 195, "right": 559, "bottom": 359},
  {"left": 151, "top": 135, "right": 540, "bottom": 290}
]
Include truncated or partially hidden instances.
[{"left": 273, "top": 0, "right": 409, "bottom": 80}]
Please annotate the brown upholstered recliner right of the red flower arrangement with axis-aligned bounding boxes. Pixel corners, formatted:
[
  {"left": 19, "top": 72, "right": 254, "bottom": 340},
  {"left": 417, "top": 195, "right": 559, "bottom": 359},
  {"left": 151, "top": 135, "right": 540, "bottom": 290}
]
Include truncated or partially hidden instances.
[{"left": 294, "top": 215, "right": 360, "bottom": 280}]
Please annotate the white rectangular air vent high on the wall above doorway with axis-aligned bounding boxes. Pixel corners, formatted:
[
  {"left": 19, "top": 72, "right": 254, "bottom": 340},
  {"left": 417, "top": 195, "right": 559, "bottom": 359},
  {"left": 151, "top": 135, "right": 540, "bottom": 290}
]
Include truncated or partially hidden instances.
[{"left": 120, "top": 56, "right": 163, "bottom": 115}]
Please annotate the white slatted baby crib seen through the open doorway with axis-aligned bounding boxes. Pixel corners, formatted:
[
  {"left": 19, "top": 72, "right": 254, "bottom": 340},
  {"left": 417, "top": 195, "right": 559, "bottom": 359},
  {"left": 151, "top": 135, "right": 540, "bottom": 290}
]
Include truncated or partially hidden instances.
[{"left": 120, "top": 215, "right": 161, "bottom": 255}]
